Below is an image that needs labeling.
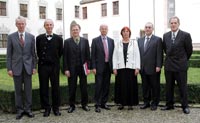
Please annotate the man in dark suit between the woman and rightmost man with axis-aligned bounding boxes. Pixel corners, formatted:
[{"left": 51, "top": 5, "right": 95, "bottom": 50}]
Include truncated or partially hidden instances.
[{"left": 138, "top": 22, "right": 163, "bottom": 110}]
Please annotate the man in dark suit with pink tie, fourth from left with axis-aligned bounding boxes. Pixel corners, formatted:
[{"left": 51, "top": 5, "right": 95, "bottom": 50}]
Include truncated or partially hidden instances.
[{"left": 91, "top": 24, "right": 114, "bottom": 112}]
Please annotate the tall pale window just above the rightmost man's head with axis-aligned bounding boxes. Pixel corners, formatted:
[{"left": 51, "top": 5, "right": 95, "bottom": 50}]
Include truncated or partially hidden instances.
[{"left": 167, "top": 0, "right": 175, "bottom": 27}]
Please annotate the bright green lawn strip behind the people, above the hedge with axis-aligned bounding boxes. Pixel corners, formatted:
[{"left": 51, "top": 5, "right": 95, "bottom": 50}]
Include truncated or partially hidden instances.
[{"left": 0, "top": 68, "right": 200, "bottom": 90}]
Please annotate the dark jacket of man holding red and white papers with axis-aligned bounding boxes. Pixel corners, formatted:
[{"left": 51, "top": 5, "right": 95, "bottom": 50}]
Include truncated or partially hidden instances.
[{"left": 63, "top": 37, "right": 90, "bottom": 71}]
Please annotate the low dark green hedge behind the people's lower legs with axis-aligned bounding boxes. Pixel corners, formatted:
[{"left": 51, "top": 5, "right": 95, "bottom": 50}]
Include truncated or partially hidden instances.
[{"left": 0, "top": 83, "right": 200, "bottom": 112}]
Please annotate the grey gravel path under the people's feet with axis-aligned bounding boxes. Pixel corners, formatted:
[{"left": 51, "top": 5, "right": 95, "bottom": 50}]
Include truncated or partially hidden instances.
[{"left": 0, "top": 104, "right": 200, "bottom": 123}]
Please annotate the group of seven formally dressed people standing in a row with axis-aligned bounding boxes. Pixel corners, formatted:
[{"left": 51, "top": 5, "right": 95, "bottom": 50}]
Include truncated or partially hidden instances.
[{"left": 7, "top": 16, "right": 193, "bottom": 119}]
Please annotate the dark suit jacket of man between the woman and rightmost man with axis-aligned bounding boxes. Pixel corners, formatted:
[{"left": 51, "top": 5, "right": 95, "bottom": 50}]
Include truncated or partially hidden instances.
[{"left": 138, "top": 35, "right": 163, "bottom": 74}]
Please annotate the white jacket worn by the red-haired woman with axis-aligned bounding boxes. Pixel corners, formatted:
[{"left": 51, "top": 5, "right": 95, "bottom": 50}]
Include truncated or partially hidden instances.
[{"left": 113, "top": 40, "right": 140, "bottom": 69}]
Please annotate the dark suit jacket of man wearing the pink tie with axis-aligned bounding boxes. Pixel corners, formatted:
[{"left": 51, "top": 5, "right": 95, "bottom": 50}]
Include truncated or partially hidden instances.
[{"left": 91, "top": 36, "right": 114, "bottom": 73}]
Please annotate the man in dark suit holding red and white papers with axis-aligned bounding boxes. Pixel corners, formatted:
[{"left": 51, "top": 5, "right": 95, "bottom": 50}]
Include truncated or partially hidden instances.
[{"left": 63, "top": 24, "right": 90, "bottom": 113}]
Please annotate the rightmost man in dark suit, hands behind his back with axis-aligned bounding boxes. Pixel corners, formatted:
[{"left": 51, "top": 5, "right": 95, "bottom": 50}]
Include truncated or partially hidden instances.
[{"left": 162, "top": 16, "right": 193, "bottom": 114}]
